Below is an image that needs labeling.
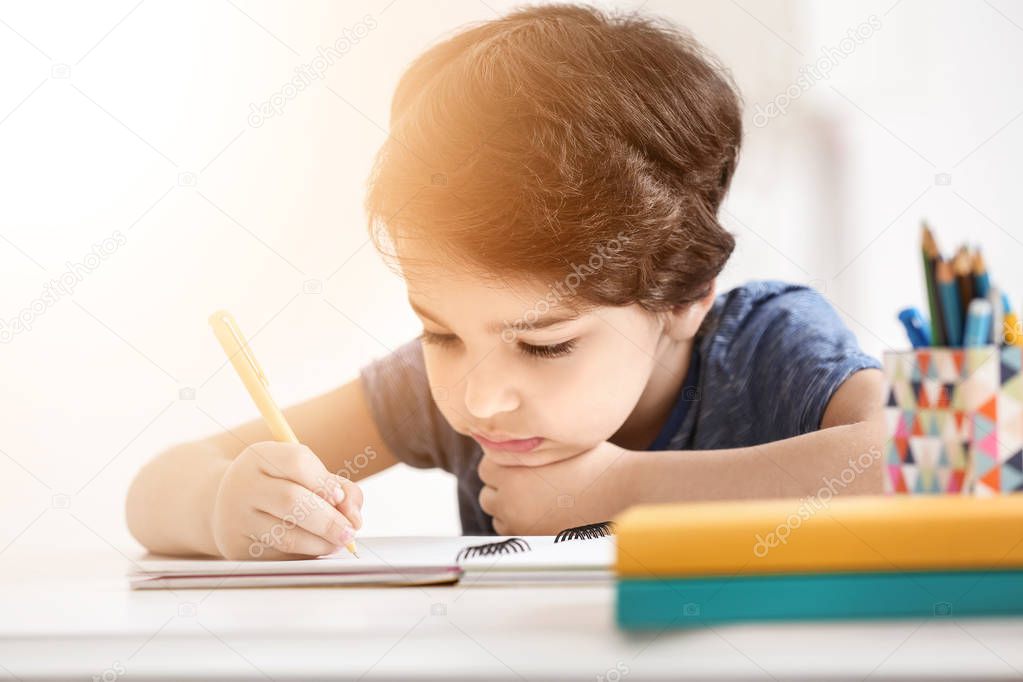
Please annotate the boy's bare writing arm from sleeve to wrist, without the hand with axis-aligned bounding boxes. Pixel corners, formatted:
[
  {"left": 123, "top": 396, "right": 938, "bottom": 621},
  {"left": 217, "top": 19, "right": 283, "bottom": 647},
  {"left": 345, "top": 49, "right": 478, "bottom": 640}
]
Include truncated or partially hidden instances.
[{"left": 126, "top": 378, "right": 396, "bottom": 555}]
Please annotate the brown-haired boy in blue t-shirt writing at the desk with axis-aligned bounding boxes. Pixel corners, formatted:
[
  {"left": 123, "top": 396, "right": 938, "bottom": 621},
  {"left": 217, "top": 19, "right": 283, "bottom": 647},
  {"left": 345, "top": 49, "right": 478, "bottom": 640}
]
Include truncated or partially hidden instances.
[{"left": 128, "top": 6, "right": 885, "bottom": 558}]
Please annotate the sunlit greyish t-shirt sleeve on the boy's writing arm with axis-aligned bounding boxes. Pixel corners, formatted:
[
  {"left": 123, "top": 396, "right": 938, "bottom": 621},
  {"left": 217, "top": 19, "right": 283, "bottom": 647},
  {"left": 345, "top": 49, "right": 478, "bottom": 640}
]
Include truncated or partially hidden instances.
[{"left": 359, "top": 338, "right": 466, "bottom": 471}]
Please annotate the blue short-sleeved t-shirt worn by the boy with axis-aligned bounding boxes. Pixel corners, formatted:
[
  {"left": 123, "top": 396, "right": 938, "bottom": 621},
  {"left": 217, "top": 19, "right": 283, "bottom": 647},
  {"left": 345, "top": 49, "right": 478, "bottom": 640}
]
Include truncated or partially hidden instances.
[{"left": 360, "top": 281, "right": 881, "bottom": 535}]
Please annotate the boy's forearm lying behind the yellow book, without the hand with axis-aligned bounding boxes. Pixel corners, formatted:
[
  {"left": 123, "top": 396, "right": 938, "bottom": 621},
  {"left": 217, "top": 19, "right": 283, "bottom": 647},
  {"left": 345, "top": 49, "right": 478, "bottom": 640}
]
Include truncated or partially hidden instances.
[{"left": 627, "top": 420, "right": 886, "bottom": 504}]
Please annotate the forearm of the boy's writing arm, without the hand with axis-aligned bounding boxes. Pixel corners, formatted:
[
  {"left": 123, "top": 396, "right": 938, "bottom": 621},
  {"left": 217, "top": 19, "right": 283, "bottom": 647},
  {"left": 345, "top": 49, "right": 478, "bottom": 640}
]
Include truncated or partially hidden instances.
[{"left": 126, "top": 442, "right": 231, "bottom": 556}]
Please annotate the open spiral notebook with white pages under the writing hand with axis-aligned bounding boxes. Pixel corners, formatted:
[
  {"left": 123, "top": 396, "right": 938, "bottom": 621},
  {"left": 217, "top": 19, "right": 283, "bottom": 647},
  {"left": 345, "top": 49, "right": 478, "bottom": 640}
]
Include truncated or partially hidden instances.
[{"left": 129, "top": 521, "right": 615, "bottom": 590}]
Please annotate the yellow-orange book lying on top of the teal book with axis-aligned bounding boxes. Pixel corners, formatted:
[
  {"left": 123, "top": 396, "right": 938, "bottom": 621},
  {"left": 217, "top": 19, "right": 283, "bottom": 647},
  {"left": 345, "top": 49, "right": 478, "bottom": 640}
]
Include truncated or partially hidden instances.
[{"left": 615, "top": 495, "right": 1023, "bottom": 578}]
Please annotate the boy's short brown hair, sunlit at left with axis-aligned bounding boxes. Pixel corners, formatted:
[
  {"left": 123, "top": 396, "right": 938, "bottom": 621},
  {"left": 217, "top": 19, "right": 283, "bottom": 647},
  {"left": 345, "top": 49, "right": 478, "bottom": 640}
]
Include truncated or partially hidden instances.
[{"left": 366, "top": 5, "right": 742, "bottom": 311}]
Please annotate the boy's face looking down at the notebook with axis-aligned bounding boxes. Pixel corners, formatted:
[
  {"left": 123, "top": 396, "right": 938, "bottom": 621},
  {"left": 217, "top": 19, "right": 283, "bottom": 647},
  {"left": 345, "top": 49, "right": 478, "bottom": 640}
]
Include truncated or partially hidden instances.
[{"left": 405, "top": 248, "right": 705, "bottom": 465}]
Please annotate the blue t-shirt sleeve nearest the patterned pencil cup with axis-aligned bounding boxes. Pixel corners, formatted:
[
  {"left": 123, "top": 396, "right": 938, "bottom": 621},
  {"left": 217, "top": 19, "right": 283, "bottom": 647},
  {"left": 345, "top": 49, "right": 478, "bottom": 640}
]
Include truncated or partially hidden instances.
[{"left": 739, "top": 286, "right": 881, "bottom": 443}]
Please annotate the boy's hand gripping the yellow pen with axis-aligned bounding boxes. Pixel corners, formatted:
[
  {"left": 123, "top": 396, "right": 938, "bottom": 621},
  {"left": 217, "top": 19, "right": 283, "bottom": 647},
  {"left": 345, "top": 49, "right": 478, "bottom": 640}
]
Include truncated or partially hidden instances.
[{"left": 213, "top": 442, "right": 362, "bottom": 559}]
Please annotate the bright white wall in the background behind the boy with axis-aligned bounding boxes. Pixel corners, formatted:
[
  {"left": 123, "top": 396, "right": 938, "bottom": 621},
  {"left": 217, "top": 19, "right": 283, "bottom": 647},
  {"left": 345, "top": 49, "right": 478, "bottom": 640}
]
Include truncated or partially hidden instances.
[{"left": 0, "top": 0, "right": 1023, "bottom": 556}]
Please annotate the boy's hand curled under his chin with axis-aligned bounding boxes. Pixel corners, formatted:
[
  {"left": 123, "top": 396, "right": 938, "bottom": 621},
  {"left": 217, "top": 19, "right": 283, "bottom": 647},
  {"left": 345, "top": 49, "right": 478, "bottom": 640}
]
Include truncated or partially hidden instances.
[{"left": 479, "top": 442, "right": 635, "bottom": 535}]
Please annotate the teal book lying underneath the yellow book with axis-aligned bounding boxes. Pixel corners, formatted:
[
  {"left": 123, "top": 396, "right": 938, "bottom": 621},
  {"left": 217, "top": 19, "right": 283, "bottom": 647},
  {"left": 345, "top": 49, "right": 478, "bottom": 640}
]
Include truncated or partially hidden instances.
[{"left": 616, "top": 571, "right": 1023, "bottom": 630}]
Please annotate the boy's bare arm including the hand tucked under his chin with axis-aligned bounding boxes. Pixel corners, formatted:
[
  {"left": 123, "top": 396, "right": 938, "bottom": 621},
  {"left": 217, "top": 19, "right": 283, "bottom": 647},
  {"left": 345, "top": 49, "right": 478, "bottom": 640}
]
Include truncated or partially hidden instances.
[{"left": 478, "top": 369, "right": 887, "bottom": 535}]
